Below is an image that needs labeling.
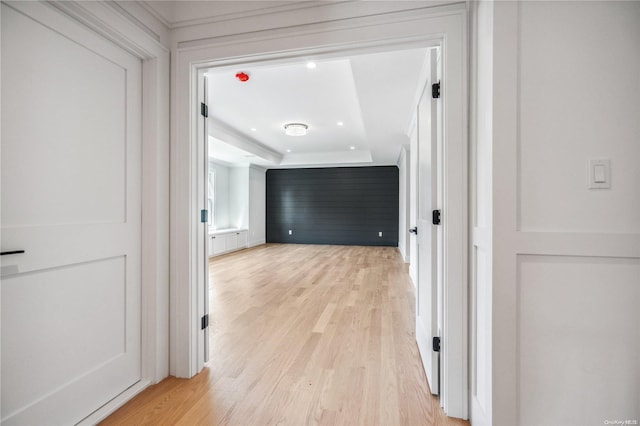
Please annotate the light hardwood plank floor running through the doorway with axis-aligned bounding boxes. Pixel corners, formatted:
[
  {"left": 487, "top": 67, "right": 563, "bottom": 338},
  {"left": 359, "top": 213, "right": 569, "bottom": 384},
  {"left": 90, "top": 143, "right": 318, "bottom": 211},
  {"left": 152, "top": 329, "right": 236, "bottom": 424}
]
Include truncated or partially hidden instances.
[{"left": 103, "top": 244, "right": 469, "bottom": 426}]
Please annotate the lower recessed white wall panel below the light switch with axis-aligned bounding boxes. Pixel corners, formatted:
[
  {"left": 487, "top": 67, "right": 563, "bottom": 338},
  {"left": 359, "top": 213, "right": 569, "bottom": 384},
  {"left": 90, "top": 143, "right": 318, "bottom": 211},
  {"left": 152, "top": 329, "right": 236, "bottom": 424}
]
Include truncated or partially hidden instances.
[{"left": 517, "top": 255, "right": 640, "bottom": 426}]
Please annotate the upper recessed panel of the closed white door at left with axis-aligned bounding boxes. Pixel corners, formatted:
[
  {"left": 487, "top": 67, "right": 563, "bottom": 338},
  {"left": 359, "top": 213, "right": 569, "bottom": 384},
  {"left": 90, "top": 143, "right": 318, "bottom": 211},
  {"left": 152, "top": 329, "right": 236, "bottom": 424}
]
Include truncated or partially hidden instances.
[{"left": 2, "top": 7, "right": 127, "bottom": 230}]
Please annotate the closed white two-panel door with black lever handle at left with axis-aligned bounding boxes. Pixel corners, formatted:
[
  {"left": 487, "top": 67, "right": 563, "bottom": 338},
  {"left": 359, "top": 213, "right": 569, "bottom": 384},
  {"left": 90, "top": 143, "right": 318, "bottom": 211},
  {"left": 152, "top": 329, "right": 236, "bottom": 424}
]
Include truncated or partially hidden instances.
[{"left": 1, "top": 2, "right": 141, "bottom": 425}]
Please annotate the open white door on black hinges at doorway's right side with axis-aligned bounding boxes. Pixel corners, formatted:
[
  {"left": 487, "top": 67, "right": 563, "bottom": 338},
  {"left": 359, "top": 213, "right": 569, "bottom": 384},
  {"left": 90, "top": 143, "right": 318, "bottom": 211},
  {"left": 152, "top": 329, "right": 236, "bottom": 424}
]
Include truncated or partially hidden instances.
[{"left": 416, "top": 49, "right": 442, "bottom": 395}]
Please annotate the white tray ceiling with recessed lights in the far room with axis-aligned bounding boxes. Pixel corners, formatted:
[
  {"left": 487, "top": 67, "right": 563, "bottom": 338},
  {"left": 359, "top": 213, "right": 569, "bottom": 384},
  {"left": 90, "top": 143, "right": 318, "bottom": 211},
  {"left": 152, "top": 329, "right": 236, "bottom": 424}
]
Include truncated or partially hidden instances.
[{"left": 207, "top": 48, "right": 427, "bottom": 168}]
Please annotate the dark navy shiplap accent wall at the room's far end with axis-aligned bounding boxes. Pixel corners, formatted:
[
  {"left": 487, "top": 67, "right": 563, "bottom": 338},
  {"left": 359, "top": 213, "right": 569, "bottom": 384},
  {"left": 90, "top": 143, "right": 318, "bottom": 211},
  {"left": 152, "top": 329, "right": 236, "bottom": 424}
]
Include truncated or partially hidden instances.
[{"left": 266, "top": 166, "right": 398, "bottom": 246}]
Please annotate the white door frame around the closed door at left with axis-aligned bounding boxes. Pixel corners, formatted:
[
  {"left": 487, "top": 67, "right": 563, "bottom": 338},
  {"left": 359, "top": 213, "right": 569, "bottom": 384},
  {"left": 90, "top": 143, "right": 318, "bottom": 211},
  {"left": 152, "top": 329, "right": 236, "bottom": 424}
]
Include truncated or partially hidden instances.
[{"left": 6, "top": 1, "right": 169, "bottom": 425}]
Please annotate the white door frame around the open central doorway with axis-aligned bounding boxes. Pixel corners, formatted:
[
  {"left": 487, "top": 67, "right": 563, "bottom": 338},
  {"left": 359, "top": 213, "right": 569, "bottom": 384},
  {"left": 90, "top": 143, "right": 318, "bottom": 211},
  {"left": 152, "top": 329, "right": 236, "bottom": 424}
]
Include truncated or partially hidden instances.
[{"left": 170, "top": 3, "right": 468, "bottom": 418}]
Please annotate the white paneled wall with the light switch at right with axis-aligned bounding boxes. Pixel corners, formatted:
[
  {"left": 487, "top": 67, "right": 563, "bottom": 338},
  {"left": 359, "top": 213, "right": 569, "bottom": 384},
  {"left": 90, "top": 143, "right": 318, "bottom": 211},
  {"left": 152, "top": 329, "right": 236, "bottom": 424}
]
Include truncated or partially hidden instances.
[{"left": 488, "top": 2, "right": 640, "bottom": 425}]
